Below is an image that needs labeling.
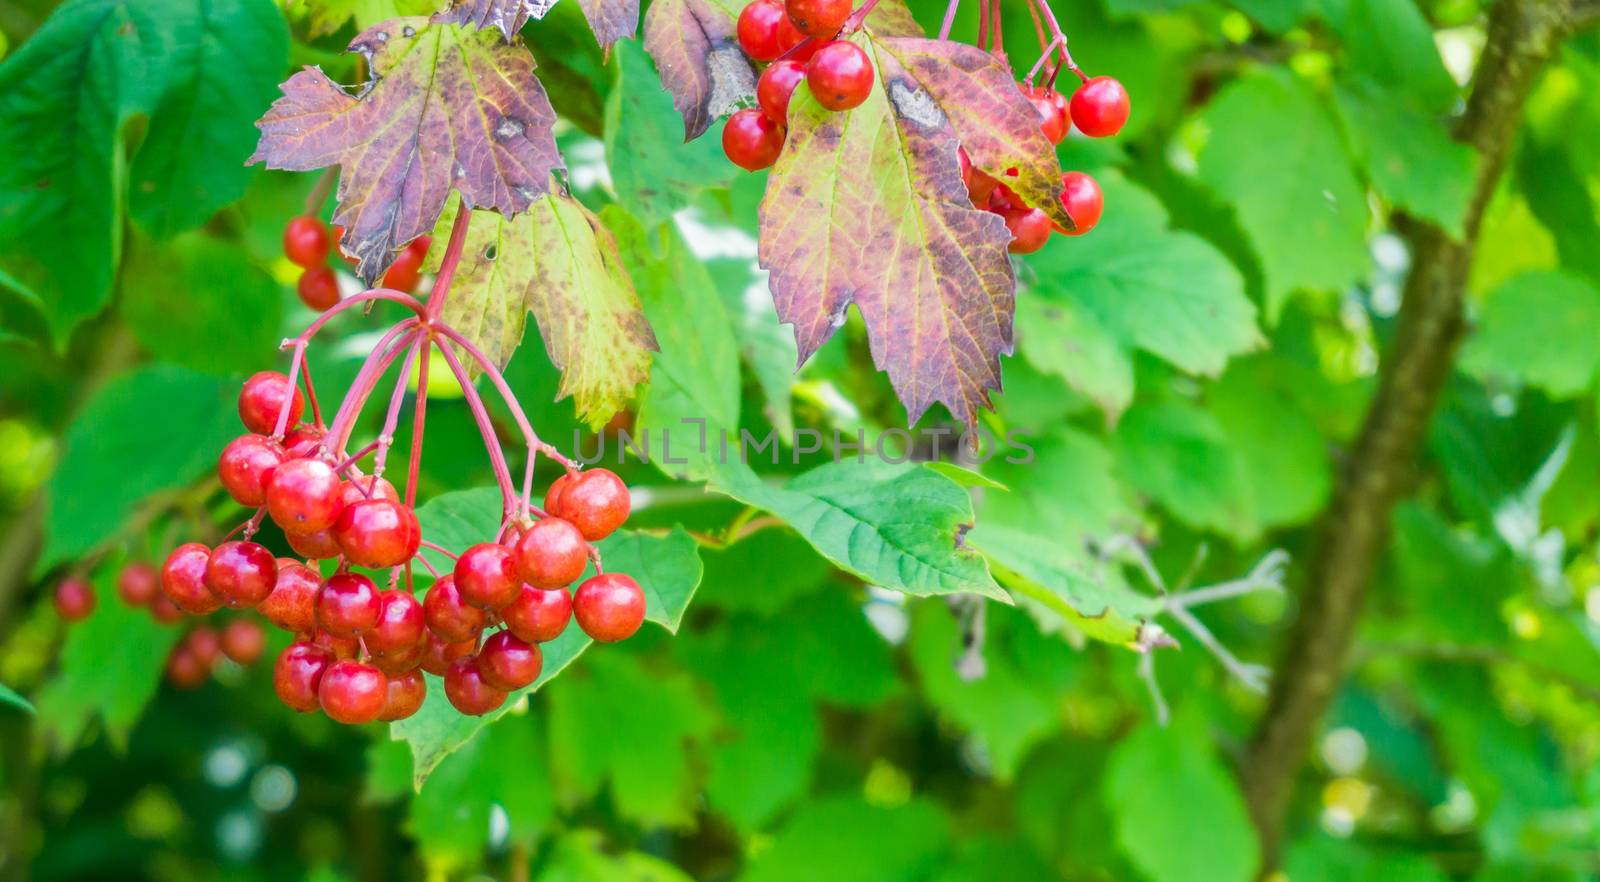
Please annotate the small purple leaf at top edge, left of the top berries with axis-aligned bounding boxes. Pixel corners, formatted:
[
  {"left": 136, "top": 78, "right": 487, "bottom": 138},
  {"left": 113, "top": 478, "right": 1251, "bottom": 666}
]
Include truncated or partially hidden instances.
[{"left": 645, "top": 0, "right": 755, "bottom": 141}]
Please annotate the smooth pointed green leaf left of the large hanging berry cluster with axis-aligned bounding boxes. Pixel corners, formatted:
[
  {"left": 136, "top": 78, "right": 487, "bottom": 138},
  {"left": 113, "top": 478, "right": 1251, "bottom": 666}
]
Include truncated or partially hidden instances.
[{"left": 35, "top": 365, "right": 243, "bottom": 573}]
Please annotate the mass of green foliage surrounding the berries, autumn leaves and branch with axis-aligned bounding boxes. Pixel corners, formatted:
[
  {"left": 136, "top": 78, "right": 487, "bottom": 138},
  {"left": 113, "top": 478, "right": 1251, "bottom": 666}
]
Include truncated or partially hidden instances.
[{"left": 0, "top": 0, "right": 1600, "bottom": 882}]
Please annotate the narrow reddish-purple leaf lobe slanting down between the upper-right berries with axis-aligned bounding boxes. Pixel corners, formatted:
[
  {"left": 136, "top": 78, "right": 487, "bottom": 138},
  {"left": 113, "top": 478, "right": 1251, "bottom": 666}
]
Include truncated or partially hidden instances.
[{"left": 874, "top": 37, "right": 1074, "bottom": 229}]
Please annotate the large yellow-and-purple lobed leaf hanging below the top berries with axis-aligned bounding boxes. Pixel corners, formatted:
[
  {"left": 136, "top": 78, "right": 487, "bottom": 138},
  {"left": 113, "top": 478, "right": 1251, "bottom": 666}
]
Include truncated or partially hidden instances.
[{"left": 758, "top": 32, "right": 1016, "bottom": 424}]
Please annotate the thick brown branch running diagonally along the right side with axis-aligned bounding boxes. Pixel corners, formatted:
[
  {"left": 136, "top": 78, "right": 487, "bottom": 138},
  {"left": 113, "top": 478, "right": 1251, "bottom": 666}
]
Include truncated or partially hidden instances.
[{"left": 1240, "top": 0, "right": 1589, "bottom": 876}]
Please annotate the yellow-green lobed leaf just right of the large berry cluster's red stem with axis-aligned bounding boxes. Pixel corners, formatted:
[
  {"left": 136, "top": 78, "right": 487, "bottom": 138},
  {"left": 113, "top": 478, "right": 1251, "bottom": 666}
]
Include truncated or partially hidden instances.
[{"left": 429, "top": 196, "right": 658, "bottom": 427}]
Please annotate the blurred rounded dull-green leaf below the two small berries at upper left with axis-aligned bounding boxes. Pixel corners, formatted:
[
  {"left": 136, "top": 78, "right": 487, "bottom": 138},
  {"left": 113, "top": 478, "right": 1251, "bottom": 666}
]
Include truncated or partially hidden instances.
[{"left": 122, "top": 234, "right": 283, "bottom": 373}]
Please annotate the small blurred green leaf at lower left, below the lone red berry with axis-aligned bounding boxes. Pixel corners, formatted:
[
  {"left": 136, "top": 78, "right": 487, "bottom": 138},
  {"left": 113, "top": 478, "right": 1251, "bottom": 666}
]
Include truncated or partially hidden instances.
[{"left": 34, "top": 567, "right": 182, "bottom": 754}]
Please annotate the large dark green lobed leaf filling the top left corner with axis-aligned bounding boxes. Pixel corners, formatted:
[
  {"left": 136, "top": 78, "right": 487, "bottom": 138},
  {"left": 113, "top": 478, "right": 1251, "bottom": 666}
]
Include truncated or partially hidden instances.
[{"left": 0, "top": 0, "right": 288, "bottom": 346}]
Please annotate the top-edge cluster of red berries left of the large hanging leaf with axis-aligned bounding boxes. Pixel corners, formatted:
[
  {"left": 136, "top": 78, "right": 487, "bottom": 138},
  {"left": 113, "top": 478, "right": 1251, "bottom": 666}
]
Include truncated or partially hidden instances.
[{"left": 722, "top": 0, "right": 872, "bottom": 171}]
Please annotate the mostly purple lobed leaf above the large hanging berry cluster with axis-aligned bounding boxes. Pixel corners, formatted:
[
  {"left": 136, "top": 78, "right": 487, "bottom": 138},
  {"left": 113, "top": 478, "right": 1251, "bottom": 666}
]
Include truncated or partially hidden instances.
[{"left": 250, "top": 18, "right": 562, "bottom": 285}]
